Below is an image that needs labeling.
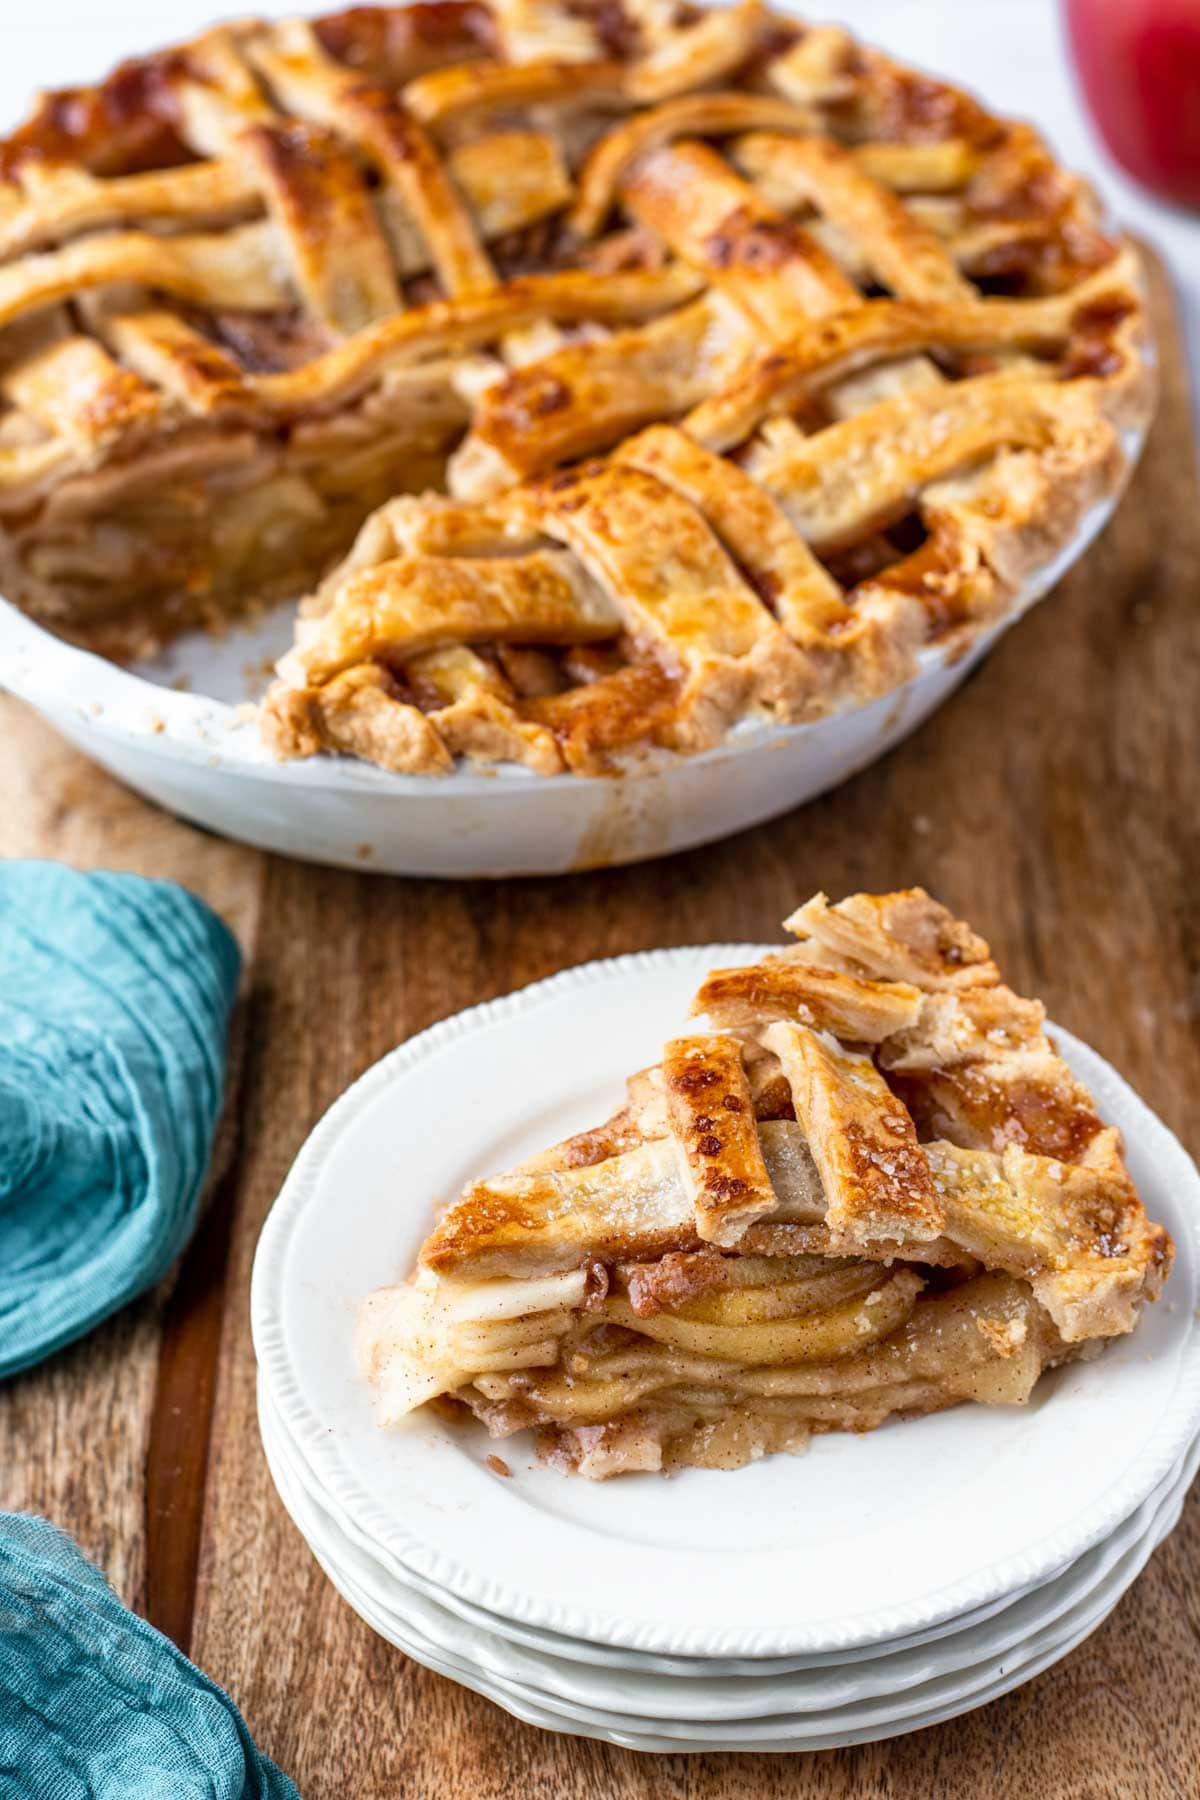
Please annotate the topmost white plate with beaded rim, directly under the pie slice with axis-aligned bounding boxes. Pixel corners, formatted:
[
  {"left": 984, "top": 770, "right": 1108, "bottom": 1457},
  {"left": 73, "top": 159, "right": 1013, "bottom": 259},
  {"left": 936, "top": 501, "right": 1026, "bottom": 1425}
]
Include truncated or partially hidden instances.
[{"left": 252, "top": 945, "right": 1200, "bottom": 1658}]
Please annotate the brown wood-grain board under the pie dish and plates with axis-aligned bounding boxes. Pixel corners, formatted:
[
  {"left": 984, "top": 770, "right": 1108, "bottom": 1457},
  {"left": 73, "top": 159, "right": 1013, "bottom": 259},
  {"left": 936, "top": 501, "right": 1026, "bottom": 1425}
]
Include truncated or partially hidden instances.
[{"left": 0, "top": 257, "right": 1200, "bottom": 1800}]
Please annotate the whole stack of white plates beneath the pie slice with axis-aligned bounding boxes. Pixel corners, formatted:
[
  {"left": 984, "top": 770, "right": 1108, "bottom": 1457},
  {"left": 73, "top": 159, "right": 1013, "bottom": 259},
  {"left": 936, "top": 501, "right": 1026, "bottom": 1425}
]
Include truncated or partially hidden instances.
[{"left": 252, "top": 945, "right": 1200, "bottom": 1751}]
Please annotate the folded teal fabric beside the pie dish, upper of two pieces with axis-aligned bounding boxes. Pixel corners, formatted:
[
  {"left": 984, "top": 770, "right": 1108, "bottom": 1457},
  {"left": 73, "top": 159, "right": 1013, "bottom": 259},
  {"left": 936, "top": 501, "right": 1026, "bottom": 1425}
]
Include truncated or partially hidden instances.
[{"left": 0, "top": 862, "right": 239, "bottom": 1375}]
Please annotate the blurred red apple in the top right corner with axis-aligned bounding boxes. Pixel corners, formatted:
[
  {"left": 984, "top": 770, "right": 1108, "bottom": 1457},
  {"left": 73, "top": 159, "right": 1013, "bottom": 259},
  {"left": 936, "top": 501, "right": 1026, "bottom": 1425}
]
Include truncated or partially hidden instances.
[{"left": 1065, "top": 0, "right": 1200, "bottom": 207}]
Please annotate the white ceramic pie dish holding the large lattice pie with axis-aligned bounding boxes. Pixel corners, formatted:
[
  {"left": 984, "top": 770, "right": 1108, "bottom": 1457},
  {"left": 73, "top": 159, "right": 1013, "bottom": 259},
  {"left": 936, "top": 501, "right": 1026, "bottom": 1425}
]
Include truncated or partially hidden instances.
[{"left": 0, "top": 475, "right": 1141, "bottom": 877}]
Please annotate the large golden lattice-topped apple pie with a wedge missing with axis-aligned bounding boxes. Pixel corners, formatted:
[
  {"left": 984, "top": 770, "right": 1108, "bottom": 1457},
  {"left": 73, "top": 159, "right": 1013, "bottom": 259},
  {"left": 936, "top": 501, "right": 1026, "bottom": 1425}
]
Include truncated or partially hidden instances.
[{"left": 0, "top": 0, "right": 1151, "bottom": 774}]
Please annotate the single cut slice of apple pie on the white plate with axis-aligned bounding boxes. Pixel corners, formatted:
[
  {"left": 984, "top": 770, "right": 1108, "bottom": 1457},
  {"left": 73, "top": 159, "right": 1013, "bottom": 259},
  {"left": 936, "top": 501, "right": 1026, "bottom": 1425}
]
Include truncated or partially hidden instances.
[{"left": 358, "top": 887, "right": 1173, "bottom": 1480}]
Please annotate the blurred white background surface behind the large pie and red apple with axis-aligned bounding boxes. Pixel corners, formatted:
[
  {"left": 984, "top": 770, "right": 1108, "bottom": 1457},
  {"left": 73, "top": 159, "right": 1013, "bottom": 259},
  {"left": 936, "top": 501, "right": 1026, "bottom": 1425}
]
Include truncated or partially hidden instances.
[{"left": 0, "top": 0, "right": 1200, "bottom": 412}]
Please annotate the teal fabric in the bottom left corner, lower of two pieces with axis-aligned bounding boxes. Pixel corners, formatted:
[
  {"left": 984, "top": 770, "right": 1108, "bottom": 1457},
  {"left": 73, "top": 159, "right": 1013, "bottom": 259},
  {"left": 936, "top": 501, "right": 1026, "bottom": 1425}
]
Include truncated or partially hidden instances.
[{"left": 0, "top": 1512, "right": 299, "bottom": 1800}]
